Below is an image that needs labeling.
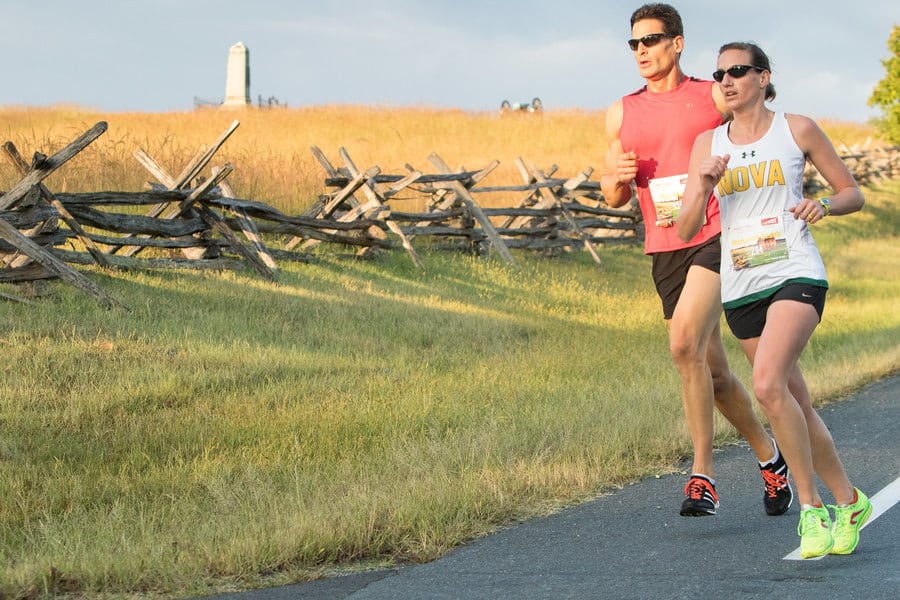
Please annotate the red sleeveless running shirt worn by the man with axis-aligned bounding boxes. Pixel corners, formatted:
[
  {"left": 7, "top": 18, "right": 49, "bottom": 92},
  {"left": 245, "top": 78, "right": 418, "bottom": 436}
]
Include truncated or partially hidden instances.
[{"left": 619, "top": 77, "right": 722, "bottom": 254}]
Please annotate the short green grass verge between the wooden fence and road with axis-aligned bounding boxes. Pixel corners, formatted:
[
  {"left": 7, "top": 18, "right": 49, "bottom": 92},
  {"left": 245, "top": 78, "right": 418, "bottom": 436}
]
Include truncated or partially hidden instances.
[{"left": 0, "top": 184, "right": 900, "bottom": 598}]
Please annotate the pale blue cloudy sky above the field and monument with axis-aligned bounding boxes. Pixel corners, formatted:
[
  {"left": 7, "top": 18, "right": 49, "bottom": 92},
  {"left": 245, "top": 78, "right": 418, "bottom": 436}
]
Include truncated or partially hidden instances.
[{"left": 0, "top": 0, "right": 900, "bottom": 121}]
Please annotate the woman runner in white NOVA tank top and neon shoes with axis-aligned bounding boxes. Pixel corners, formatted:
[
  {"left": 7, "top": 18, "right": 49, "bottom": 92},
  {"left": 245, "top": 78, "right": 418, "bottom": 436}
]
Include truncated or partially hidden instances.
[{"left": 677, "top": 43, "right": 872, "bottom": 558}]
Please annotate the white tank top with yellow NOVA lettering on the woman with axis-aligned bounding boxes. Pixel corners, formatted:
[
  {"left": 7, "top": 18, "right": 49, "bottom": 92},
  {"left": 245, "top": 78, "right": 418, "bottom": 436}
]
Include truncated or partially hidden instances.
[{"left": 711, "top": 112, "right": 828, "bottom": 308}]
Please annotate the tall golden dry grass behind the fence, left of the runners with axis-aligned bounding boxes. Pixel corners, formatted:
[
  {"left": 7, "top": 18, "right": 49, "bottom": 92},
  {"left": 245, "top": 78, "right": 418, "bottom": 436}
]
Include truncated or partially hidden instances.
[{"left": 0, "top": 106, "right": 604, "bottom": 214}]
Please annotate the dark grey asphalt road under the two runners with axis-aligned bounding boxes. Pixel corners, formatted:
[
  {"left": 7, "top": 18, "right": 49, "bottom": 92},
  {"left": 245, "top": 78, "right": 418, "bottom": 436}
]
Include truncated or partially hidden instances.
[{"left": 209, "top": 376, "right": 900, "bottom": 600}]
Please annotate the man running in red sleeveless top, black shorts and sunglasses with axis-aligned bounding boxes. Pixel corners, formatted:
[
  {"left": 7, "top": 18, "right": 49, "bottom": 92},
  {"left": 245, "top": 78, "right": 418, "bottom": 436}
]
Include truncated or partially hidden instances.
[{"left": 600, "top": 4, "right": 793, "bottom": 516}]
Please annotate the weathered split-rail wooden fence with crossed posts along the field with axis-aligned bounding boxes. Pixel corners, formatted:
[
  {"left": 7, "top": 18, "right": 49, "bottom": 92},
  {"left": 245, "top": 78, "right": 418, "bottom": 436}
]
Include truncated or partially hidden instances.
[{"left": 0, "top": 121, "right": 898, "bottom": 306}]
